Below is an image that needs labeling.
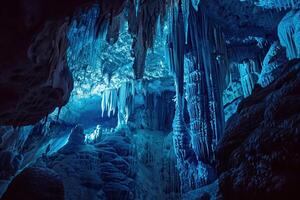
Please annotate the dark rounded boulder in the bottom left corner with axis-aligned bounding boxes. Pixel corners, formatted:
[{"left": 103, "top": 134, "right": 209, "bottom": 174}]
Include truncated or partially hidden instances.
[{"left": 1, "top": 168, "right": 64, "bottom": 200}]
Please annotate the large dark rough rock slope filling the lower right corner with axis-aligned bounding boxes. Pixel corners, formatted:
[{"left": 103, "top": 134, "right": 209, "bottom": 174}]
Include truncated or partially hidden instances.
[{"left": 217, "top": 59, "right": 300, "bottom": 200}]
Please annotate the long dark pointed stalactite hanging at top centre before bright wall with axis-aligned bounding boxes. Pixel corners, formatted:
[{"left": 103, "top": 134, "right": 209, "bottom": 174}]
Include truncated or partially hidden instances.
[{"left": 128, "top": 0, "right": 168, "bottom": 79}]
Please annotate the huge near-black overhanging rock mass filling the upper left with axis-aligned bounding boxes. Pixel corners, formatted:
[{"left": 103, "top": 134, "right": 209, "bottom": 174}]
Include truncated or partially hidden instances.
[{"left": 0, "top": 0, "right": 78, "bottom": 126}]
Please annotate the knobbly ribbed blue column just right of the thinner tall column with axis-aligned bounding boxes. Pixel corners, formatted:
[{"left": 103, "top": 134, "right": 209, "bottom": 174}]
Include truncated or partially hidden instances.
[{"left": 185, "top": 55, "right": 212, "bottom": 162}]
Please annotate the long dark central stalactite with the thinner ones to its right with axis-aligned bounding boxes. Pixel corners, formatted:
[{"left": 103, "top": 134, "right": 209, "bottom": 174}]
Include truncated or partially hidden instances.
[{"left": 128, "top": 0, "right": 200, "bottom": 79}]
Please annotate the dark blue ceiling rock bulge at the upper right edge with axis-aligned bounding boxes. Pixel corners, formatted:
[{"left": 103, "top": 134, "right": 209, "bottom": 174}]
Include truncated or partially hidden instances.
[{"left": 200, "top": 0, "right": 285, "bottom": 39}]
